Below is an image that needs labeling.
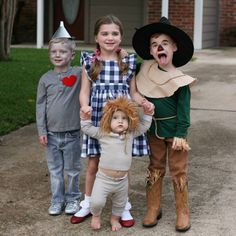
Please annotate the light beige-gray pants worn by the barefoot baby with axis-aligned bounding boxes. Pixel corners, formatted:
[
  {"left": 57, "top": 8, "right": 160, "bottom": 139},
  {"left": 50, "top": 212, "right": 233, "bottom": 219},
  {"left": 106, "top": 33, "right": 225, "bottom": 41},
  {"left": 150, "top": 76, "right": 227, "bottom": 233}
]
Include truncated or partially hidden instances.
[{"left": 91, "top": 170, "right": 128, "bottom": 216}]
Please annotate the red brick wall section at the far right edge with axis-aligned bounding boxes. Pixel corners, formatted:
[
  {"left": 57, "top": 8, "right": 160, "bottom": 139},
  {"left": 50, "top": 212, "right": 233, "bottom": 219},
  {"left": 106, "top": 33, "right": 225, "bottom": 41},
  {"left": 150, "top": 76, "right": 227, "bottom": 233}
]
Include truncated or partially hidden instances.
[{"left": 219, "top": 0, "right": 236, "bottom": 46}]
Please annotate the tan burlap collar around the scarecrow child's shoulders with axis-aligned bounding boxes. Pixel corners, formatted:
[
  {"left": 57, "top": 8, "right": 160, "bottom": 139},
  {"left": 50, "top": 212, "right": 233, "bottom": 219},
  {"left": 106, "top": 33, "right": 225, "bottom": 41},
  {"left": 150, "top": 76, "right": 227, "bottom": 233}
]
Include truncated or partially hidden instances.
[{"left": 136, "top": 60, "right": 196, "bottom": 98}]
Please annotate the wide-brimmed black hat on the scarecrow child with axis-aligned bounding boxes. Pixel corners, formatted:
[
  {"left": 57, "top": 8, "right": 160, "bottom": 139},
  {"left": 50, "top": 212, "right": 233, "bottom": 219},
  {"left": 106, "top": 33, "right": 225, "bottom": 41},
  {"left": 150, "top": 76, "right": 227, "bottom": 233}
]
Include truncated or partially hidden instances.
[{"left": 132, "top": 17, "right": 194, "bottom": 67}]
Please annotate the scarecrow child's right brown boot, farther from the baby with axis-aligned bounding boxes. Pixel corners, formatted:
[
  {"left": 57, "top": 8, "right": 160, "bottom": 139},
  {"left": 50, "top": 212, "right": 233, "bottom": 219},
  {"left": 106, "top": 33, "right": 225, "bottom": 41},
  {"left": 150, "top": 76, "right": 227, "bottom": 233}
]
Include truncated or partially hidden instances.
[{"left": 173, "top": 183, "right": 191, "bottom": 232}]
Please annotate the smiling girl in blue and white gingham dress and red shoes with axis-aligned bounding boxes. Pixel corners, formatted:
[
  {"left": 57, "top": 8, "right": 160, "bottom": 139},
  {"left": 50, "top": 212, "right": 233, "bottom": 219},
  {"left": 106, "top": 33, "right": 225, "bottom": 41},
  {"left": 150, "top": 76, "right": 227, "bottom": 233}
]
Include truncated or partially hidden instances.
[{"left": 71, "top": 15, "right": 154, "bottom": 227}]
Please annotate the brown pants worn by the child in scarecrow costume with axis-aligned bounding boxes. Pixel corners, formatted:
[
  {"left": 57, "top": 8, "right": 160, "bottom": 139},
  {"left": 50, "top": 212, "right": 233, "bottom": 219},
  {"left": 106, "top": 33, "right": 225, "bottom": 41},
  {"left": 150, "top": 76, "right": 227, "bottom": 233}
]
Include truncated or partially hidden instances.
[{"left": 148, "top": 135, "right": 188, "bottom": 188}]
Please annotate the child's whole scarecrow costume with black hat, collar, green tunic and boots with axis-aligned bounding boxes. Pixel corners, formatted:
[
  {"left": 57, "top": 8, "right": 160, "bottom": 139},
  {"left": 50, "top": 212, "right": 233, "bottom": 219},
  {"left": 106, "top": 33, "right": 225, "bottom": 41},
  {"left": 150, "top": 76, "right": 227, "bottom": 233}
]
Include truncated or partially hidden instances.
[{"left": 132, "top": 17, "right": 195, "bottom": 231}]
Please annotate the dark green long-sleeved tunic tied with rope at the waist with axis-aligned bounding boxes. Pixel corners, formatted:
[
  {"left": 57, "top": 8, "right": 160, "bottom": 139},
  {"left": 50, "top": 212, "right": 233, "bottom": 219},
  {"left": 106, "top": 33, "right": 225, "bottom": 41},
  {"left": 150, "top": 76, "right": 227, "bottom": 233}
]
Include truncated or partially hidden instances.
[{"left": 146, "top": 85, "right": 191, "bottom": 138}]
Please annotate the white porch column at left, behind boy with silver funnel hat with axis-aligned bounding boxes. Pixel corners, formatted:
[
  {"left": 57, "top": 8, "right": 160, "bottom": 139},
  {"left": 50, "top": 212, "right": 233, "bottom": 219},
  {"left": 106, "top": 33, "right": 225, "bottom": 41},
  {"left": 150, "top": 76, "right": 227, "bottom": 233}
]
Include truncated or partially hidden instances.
[{"left": 37, "top": 0, "right": 44, "bottom": 48}]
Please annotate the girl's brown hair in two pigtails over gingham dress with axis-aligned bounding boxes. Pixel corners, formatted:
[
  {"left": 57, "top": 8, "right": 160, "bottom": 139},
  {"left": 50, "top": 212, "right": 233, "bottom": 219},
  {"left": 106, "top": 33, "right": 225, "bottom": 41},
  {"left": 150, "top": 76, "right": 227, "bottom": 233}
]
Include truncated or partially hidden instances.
[{"left": 89, "top": 15, "right": 128, "bottom": 81}]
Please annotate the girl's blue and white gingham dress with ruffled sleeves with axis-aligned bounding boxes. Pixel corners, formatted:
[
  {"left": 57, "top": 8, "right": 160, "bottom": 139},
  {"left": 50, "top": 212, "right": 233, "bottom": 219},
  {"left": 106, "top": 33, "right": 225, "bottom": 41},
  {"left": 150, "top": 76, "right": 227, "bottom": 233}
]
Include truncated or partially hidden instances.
[{"left": 81, "top": 51, "right": 149, "bottom": 157}]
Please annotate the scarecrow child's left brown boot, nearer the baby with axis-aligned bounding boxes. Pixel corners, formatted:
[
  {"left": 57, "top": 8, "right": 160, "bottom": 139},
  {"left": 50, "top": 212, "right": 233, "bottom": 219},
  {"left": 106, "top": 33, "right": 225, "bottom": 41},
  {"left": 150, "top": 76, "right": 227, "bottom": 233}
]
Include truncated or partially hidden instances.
[{"left": 143, "top": 172, "right": 163, "bottom": 227}]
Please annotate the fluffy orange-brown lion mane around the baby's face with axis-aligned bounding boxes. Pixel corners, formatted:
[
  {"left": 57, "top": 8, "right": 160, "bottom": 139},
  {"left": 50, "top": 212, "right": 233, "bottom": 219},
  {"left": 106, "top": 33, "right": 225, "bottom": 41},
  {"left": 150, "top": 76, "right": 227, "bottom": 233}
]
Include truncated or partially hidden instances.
[{"left": 100, "top": 97, "right": 139, "bottom": 133}]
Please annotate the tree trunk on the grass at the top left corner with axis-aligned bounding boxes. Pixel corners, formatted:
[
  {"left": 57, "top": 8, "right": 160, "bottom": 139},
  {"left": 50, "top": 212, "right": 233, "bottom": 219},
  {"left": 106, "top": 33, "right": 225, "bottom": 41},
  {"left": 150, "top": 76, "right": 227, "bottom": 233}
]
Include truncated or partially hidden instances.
[{"left": 0, "top": 0, "right": 17, "bottom": 61}]
